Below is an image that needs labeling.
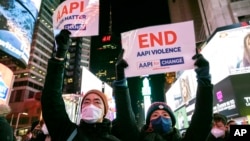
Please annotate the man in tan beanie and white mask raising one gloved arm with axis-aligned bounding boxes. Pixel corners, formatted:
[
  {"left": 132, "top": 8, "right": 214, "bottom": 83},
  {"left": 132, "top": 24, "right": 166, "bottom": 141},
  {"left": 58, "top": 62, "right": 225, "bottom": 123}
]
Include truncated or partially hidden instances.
[{"left": 41, "top": 30, "right": 119, "bottom": 141}]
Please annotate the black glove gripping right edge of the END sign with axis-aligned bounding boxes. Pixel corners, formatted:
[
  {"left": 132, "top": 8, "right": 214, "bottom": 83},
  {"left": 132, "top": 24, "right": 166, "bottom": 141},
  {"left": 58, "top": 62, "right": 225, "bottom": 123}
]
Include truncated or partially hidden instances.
[{"left": 192, "top": 54, "right": 211, "bottom": 81}]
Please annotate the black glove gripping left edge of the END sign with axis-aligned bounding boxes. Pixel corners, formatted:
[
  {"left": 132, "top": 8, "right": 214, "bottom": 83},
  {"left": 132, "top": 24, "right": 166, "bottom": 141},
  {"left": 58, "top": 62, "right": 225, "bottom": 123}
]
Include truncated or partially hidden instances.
[{"left": 115, "top": 49, "right": 128, "bottom": 80}]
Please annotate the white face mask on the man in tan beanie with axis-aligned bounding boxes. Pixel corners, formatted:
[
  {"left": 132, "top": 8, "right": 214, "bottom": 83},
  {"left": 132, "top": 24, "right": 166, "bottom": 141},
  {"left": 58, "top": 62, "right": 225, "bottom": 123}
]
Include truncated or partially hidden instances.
[{"left": 81, "top": 104, "right": 103, "bottom": 123}]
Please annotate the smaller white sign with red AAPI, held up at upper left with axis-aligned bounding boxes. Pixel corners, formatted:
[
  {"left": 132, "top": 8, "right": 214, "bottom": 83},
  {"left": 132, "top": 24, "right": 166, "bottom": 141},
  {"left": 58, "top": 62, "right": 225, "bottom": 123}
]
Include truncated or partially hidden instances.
[{"left": 52, "top": 0, "right": 99, "bottom": 37}]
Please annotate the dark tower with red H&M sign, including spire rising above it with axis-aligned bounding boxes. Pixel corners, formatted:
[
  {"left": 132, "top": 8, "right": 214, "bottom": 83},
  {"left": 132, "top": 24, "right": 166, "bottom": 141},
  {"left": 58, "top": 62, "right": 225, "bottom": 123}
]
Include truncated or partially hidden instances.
[{"left": 89, "top": 0, "right": 114, "bottom": 85}]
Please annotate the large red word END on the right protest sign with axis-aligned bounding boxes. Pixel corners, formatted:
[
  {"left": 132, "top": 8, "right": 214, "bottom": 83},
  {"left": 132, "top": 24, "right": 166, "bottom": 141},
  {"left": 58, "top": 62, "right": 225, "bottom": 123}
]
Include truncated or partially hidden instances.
[{"left": 138, "top": 31, "right": 177, "bottom": 48}]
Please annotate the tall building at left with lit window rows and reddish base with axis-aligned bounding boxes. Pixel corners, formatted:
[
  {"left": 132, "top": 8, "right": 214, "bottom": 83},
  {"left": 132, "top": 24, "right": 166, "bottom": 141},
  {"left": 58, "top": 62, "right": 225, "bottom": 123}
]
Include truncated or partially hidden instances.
[{"left": 0, "top": 0, "right": 59, "bottom": 135}]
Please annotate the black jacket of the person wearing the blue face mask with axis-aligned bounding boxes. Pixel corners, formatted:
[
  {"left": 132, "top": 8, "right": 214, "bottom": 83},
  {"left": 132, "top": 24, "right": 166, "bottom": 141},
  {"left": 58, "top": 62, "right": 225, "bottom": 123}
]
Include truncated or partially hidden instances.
[{"left": 113, "top": 72, "right": 213, "bottom": 141}]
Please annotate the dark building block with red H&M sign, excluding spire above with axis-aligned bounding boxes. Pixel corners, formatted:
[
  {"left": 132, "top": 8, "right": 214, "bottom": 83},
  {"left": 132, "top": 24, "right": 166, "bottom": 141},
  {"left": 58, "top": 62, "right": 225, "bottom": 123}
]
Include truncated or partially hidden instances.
[{"left": 90, "top": 34, "right": 121, "bottom": 86}]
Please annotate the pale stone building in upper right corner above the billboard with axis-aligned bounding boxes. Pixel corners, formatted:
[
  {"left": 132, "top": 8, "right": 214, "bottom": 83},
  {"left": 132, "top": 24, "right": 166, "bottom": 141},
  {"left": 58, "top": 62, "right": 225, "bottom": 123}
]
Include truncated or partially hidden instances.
[{"left": 198, "top": 0, "right": 250, "bottom": 36}]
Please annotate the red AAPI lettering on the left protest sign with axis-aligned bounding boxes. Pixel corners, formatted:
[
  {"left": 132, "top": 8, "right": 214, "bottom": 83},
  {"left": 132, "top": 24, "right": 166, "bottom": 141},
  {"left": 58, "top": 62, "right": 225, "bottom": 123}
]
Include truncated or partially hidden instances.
[{"left": 56, "top": 1, "right": 84, "bottom": 21}]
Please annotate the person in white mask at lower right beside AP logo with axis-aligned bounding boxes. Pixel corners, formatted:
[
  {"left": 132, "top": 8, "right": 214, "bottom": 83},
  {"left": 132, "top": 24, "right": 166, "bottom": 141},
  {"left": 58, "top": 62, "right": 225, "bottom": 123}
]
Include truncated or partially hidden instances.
[{"left": 207, "top": 113, "right": 230, "bottom": 141}]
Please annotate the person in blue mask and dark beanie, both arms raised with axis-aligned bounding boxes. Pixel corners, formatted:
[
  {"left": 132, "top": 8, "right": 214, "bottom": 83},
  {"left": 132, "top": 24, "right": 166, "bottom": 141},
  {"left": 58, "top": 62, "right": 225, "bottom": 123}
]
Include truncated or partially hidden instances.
[{"left": 112, "top": 50, "right": 213, "bottom": 141}]
